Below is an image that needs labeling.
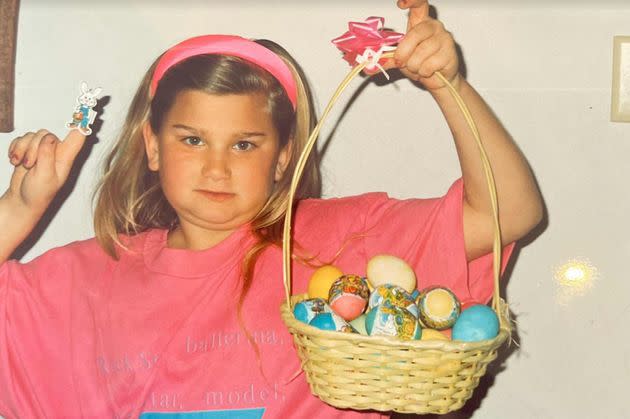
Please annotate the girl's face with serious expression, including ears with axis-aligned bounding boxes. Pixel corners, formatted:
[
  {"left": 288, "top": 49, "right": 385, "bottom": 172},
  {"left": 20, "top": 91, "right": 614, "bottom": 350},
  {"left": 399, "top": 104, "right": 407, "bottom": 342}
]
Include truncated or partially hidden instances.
[{"left": 144, "top": 90, "right": 288, "bottom": 249}]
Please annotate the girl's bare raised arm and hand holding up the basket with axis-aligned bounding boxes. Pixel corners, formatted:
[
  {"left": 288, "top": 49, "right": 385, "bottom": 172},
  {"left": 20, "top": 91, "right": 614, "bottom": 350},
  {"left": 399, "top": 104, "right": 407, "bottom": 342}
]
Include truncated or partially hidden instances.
[{"left": 384, "top": 0, "right": 543, "bottom": 260}]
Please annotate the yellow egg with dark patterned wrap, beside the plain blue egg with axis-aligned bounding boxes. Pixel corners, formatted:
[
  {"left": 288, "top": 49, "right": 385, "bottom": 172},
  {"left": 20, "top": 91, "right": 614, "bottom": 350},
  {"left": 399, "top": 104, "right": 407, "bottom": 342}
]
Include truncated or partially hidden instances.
[{"left": 418, "top": 287, "right": 460, "bottom": 330}]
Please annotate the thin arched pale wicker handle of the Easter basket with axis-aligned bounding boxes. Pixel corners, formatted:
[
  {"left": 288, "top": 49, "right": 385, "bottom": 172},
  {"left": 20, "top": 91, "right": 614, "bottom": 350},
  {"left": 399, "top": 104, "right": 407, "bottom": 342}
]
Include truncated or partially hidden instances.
[{"left": 282, "top": 51, "right": 504, "bottom": 326}]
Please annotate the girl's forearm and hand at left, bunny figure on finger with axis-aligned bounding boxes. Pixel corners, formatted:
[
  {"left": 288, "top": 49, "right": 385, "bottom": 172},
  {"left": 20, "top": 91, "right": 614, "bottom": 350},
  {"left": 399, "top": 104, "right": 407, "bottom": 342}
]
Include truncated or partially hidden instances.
[{"left": 0, "top": 130, "right": 85, "bottom": 263}]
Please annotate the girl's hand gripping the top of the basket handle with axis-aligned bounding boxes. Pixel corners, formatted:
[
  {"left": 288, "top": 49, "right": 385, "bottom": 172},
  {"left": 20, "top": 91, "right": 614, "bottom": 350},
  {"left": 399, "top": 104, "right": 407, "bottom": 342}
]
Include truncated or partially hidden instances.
[{"left": 383, "top": 0, "right": 460, "bottom": 91}]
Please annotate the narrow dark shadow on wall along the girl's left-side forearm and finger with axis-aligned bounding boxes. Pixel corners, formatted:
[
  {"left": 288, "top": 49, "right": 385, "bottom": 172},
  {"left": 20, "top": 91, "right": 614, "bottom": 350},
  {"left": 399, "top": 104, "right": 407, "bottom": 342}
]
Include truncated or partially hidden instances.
[{"left": 11, "top": 96, "right": 111, "bottom": 260}]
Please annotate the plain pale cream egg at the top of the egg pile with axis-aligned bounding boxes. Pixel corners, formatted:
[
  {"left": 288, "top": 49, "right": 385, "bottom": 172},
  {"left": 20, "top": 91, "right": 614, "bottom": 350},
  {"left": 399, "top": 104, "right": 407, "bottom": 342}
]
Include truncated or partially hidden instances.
[{"left": 367, "top": 255, "right": 416, "bottom": 292}]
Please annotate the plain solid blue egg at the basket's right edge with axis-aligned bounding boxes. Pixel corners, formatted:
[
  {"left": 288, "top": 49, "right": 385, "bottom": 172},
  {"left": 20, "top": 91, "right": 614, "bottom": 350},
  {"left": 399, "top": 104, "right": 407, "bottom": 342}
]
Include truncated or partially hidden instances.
[{"left": 453, "top": 304, "right": 499, "bottom": 342}]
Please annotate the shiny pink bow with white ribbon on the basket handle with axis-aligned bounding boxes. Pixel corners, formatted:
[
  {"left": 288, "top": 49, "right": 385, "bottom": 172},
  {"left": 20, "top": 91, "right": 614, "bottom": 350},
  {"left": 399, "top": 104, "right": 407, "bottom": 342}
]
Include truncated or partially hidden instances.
[{"left": 332, "top": 16, "right": 404, "bottom": 80}]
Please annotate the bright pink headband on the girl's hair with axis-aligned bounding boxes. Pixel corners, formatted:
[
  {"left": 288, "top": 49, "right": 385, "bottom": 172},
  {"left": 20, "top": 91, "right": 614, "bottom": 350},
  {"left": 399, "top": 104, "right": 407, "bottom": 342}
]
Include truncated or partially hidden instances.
[{"left": 150, "top": 35, "right": 297, "bottom": 109}]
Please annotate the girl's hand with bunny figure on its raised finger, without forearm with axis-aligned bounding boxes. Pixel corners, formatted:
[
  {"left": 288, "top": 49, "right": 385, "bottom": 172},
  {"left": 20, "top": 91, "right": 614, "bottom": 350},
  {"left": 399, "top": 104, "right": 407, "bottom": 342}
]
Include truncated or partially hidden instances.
[{"left": 2, "top": 129, "right": 85, "bottom": 221}]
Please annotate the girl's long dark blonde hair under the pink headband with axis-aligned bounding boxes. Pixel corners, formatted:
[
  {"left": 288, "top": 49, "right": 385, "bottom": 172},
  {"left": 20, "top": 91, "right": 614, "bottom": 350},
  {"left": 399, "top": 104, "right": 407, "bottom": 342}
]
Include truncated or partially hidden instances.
[{"left": 94, "top": 40, "right": 321, "bottom": 302}]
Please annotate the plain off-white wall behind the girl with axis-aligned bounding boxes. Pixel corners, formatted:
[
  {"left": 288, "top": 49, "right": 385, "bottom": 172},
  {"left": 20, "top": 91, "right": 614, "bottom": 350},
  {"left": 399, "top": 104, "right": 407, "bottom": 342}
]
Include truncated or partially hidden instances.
[{"left": 0, "top": 0, "right": 630, "bottom": 419}]
